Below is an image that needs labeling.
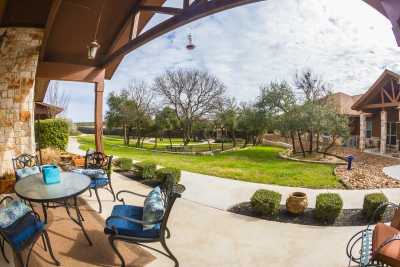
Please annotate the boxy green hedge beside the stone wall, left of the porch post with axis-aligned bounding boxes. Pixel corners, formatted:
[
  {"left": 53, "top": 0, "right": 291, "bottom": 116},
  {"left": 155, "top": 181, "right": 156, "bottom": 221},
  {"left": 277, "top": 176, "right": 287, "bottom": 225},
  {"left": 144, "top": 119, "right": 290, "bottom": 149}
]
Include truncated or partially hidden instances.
[{"left": 35, "top": 119, "right": 69, "bottom": 150}]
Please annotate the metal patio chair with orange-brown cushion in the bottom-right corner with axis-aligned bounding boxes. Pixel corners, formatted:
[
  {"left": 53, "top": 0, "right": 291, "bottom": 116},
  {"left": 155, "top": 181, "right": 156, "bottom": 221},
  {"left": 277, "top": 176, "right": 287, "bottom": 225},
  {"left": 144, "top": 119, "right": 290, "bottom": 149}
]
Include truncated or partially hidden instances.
[{"left": 346, "top": 202, "right": 400, "bottom": 267}]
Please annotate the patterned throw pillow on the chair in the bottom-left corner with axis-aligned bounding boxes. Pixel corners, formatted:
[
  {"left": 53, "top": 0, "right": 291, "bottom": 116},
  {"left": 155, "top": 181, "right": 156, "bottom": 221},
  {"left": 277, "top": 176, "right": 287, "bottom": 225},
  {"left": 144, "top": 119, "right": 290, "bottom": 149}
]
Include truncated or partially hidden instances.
[{"left": 0, "top": 200, "right": 32, "bottom": 228}]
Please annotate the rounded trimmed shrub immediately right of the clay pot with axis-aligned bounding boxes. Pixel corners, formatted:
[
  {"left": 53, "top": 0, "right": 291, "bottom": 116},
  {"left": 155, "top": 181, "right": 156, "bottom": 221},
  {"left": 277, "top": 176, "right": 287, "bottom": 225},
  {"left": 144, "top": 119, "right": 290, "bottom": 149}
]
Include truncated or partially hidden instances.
[{"left": 315, "top": 193, "right": 343, "bottom": 223}]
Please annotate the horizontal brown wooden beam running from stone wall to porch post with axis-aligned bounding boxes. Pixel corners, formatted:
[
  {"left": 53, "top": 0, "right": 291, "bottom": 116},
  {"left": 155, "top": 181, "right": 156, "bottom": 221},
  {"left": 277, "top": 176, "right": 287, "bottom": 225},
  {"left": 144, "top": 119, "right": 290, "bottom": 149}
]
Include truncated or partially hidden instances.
[{"left": 36, "top": 61, "right": 105, "bottom": 83}]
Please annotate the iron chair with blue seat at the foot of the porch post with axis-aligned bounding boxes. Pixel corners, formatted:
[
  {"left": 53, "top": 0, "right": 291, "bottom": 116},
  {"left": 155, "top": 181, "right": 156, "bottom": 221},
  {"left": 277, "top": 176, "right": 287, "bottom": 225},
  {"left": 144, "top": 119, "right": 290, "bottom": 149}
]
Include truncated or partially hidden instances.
[{"left": 85, "top": 150, "right": 116, "bottom": 213}]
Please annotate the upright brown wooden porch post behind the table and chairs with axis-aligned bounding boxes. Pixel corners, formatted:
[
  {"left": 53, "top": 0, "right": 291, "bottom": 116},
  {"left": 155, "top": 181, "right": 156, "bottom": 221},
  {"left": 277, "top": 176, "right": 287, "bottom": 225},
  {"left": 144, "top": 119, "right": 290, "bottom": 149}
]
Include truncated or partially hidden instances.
[{"left": 94, "top": 81, "right": 104, "bottom": 152}]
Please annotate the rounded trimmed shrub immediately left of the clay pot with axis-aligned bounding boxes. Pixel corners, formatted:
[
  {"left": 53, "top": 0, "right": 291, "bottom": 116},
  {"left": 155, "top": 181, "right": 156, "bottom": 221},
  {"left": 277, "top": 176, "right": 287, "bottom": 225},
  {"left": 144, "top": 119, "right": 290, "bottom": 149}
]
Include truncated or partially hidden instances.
[{"left": 250, "top": 189, "right": 282, "bottom": 216}]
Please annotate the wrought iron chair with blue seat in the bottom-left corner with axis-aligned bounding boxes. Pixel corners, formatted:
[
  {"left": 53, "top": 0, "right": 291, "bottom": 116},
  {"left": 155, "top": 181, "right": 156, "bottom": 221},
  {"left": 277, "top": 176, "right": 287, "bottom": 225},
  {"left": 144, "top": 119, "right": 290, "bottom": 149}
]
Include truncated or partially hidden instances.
[{"left": 0, "top": 196, "right": 60, "bottom": 267}]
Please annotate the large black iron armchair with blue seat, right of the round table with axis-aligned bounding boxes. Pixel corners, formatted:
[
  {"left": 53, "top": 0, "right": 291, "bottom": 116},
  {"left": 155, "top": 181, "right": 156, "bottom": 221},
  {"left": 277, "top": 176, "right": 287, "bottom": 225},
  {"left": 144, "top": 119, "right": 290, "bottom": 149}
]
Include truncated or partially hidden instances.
[{"left": 104, "top": 182, "right": 185, "bottom": 267}]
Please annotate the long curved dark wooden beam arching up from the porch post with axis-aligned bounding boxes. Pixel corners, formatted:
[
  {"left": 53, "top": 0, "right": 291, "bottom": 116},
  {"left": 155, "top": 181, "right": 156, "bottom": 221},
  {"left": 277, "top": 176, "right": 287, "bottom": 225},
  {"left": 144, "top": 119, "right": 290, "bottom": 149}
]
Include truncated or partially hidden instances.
[{"left": 102, "top": 0, "right": 265, "bottom": 67}]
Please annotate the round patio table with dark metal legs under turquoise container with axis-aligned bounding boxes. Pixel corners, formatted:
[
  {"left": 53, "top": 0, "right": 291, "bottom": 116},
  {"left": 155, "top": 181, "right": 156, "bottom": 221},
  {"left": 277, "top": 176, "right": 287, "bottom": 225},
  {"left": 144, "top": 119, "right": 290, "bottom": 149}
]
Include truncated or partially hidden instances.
[{"left": 14, "top": 172, "right": 92, "bottom": 245}]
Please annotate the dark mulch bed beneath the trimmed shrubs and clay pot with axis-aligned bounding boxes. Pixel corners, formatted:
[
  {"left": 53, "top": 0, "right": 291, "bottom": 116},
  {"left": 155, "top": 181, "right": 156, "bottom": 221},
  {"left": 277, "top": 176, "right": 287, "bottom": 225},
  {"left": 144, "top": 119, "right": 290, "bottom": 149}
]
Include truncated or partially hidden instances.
[{"left": 228, "top": 202, "right": 393, "bottom": 226}]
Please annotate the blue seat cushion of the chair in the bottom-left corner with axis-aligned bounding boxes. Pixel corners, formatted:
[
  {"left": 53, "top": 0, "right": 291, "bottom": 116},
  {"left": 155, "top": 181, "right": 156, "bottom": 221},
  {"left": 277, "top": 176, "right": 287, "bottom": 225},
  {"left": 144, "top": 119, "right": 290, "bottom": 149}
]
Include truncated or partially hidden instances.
[{"left": 3, "top": 213, "right": 44, "bottom": 250}]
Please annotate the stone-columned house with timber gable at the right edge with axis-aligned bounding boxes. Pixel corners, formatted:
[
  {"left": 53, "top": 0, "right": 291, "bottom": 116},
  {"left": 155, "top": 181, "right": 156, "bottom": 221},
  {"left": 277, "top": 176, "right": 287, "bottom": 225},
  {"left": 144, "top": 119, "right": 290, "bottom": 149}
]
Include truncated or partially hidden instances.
[{"left": 332, "top": 70, "right": 400, "bottom": 154}]
